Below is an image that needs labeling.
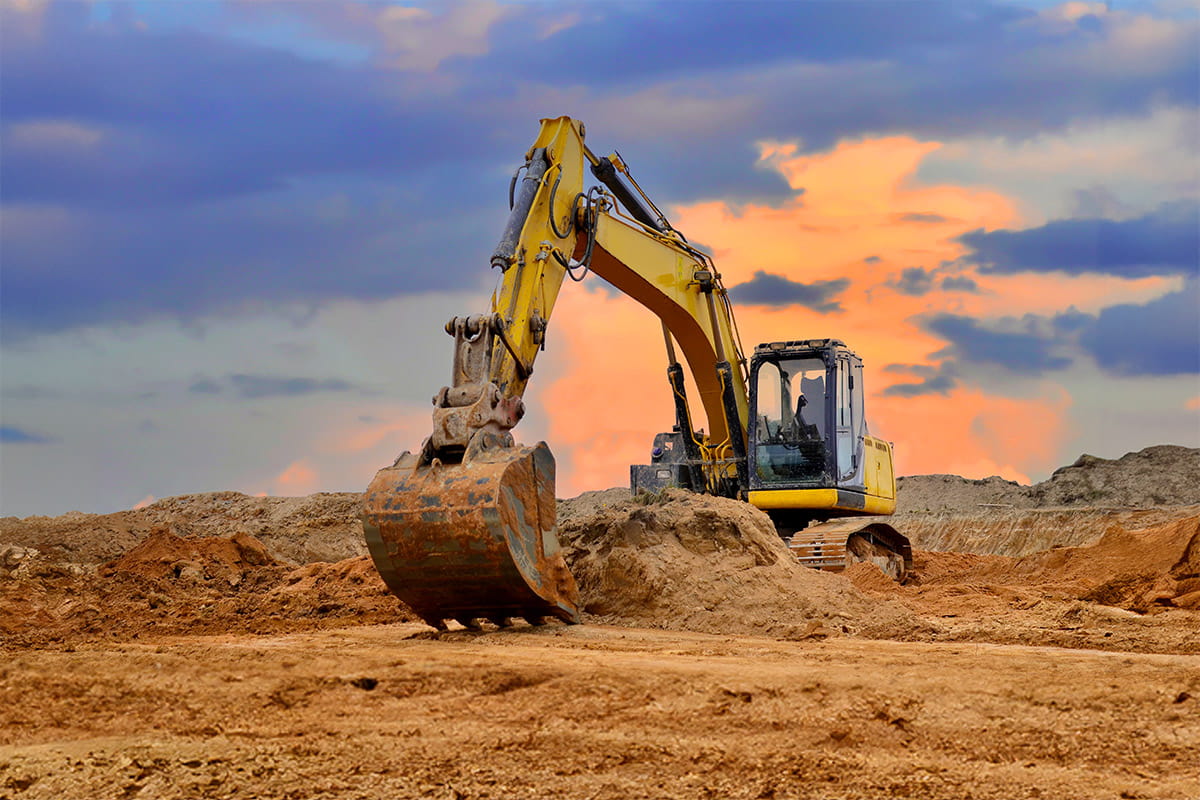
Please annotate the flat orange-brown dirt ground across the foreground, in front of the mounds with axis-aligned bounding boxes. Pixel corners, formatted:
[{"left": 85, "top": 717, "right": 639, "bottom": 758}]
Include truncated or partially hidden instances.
[{"left": 0, "top": 624, "right": 1200, "bottom": 800}]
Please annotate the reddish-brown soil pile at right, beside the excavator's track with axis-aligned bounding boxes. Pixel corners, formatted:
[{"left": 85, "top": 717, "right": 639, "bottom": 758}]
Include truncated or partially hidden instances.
[{"left": 844, "top": 515, "right": 1200, "bottom": 654}]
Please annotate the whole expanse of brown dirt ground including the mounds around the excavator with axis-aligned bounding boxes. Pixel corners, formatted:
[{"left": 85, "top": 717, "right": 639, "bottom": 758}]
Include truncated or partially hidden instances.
[{"left": 0, "top": 447, "right": 1200, "bottom": 800}]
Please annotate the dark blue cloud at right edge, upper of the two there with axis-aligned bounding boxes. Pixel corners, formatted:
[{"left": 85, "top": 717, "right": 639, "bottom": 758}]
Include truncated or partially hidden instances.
[{"left": 960, "top": 201, "right": 1200, "bottom": 278}]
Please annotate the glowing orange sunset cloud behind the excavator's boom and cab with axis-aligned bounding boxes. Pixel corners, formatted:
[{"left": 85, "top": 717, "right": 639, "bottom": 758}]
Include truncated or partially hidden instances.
[{"left": 534, "top": 137, "right": 1108, "bottom": 495}]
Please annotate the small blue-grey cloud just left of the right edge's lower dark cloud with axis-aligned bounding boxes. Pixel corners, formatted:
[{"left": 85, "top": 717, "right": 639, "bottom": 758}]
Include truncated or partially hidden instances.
[{"left": 922, "top": 313, "right": 1070, "bottom": 375}]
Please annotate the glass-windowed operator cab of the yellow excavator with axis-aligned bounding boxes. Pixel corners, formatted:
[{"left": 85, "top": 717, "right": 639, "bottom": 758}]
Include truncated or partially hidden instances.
[{"left": 748, "top": 339, "right": 866, "bottom": 501}]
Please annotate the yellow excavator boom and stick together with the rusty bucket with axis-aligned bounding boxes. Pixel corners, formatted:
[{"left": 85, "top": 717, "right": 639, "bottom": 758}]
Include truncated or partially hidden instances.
[{"left": 362, "top": 116, "right": 749, "bottom": 628}]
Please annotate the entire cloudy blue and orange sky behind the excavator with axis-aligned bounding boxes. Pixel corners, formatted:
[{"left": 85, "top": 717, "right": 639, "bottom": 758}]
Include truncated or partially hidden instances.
[{"left": 0, "top": 0, "right": 1200, "bottom": 516}]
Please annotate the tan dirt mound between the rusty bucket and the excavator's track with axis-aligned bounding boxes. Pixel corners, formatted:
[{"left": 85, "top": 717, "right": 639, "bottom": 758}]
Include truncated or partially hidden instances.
[{"left": 559, "top": 489, "right": 906, "bottom": 638}]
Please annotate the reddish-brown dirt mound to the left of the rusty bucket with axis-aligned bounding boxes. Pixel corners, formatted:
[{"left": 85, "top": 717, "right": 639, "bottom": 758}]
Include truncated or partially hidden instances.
[{"left": 0, "top": 529, "right": 413, "bottom": 646}]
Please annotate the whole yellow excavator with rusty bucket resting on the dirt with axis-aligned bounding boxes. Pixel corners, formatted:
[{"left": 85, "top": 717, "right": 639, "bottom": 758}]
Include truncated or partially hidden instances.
[{"left": 361, "top": 116, "right": 912, "bottom": 630}]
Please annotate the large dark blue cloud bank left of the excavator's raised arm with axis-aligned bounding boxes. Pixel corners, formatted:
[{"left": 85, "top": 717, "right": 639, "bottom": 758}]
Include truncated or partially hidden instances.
[{"left": 0, "top": 4, "right": 523, "bottom": 342}]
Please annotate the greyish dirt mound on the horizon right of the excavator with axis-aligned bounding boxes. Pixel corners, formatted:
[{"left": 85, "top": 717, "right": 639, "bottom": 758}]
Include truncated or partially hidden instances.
[{"left": 896, "top": 445, "right": 1200, "bottom": 513}]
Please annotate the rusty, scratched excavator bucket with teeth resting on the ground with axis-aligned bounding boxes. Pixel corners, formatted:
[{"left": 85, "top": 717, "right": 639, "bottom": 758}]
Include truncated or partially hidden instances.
[{"left": 362, "top": 443, "right": 580, "bottom": 630}]
